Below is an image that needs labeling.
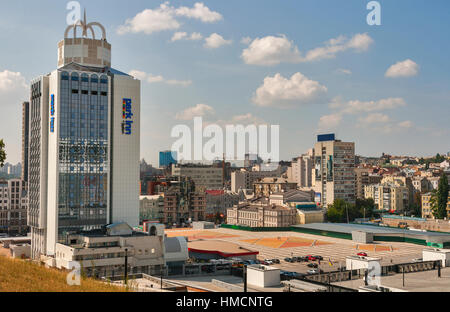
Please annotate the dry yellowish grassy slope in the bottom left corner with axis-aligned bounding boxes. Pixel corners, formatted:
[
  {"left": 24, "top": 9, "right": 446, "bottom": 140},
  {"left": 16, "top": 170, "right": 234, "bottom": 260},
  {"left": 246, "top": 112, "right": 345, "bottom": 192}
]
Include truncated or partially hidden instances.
[{"left": 0, "top": 256, "right": 126, "bottom": 292}]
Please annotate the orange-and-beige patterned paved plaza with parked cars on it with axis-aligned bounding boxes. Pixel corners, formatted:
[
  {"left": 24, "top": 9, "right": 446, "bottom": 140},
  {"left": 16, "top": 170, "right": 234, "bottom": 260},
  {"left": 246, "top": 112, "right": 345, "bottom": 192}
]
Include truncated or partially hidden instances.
[{"left": 171, "top": 229, "right": 423, "bottom": 273}]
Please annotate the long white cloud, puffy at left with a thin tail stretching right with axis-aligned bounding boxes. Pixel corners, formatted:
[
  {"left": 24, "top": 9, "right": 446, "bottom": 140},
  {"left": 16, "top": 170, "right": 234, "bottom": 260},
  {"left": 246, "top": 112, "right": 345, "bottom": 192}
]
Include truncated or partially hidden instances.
[{"left": 241, "top": 33, "right": 373, "bottom": 66}]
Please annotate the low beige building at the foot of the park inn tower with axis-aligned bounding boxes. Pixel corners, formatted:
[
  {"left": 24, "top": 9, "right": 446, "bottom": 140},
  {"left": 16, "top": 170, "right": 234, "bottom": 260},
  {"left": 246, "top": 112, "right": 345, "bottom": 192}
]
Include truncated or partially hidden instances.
[{"left": 52, "top": 223, "right": 165, "bottom": 277}]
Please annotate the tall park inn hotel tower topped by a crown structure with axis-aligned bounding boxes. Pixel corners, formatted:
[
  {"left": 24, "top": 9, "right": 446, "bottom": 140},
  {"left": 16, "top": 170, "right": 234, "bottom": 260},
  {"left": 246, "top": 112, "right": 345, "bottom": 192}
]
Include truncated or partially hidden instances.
[{"left": 29, "top": 16, "right": 140, "bottom": 258}]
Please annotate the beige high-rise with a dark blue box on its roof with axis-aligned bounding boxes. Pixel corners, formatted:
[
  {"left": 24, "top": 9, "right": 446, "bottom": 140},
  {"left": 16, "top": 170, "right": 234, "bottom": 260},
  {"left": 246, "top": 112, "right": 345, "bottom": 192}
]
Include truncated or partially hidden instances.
[{"left": 313, "top": 134, "right": 355, "bottom": 208}]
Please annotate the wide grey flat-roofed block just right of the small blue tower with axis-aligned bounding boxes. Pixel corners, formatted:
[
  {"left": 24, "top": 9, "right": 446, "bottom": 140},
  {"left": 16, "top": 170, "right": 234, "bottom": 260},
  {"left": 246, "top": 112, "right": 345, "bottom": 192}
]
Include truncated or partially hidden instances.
[{"left": 172, "top": 164, "right": 223, "bottom": 191}]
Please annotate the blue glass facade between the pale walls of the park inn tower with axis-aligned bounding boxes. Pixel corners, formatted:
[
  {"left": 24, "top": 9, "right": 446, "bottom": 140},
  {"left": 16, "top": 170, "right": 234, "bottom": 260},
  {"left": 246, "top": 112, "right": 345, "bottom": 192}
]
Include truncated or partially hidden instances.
[{"left": 58, "top": 72, "right": 109, "bottom": 240}]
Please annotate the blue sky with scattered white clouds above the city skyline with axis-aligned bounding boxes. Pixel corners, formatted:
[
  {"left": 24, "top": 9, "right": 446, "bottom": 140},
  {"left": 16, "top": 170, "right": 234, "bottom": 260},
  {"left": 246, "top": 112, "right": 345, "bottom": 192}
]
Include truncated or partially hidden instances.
[{"left": 0, "top": 0, "right": 450, "bottom": 165}]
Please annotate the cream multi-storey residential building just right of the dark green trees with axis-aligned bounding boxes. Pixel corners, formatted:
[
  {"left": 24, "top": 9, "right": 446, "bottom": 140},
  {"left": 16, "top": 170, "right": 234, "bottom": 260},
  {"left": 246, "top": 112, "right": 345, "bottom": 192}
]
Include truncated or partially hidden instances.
[{"left": 364, "top": 183, "right": 410, "bottom": 213}]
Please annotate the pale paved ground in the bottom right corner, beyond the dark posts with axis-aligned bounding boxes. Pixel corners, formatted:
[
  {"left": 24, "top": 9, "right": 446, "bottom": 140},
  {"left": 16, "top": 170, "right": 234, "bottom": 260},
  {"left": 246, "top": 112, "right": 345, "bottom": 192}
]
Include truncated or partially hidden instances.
[{"left": 334, "top": 268, "right": 450, "bottom": 292}]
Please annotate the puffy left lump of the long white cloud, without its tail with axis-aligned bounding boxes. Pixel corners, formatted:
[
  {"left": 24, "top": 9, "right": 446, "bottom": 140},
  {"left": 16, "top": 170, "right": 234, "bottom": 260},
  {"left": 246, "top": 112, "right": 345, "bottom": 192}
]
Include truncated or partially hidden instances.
[{"left": 241, "top": 35, "right": 301, "bottom": 66}]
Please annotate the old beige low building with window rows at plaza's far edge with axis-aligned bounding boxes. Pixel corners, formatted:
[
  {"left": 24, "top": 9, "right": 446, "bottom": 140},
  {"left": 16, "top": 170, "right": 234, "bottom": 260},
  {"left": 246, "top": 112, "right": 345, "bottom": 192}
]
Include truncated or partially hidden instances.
[{"left": 227, "top": 200, "right": 297, "bottom": 227}]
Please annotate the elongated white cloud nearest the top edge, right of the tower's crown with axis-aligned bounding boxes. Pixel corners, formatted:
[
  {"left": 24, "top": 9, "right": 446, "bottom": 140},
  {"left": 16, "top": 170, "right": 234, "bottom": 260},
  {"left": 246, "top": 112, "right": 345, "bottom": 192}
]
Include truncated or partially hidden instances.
[{"left": 117, "top": 2, "right": 222, "bottom": 35}]
